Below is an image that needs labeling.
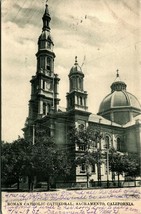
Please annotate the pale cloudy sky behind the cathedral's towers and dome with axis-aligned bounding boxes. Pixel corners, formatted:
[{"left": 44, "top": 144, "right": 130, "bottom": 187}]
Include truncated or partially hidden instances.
[{"left": 1, "top": 0, "right": 141, "bottom": 142}]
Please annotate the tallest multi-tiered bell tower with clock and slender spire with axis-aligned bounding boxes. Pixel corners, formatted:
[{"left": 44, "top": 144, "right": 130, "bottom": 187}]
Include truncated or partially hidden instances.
[{"left": 28, "top": 4, "right": 60, "bottom": 123}]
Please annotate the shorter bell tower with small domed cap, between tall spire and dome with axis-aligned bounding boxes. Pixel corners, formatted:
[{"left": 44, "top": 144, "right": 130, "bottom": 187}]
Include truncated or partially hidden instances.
[{"left": 66, "top": 56, "right": 88, "bottom": 111}]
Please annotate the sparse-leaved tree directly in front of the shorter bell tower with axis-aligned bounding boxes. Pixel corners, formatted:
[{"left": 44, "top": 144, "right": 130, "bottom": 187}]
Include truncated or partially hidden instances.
[{"left": 69, "top": 125, "right": 103, "bottom": 187}]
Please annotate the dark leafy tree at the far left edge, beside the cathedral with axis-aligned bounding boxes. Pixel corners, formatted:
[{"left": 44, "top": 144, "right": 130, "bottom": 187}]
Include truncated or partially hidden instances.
[{"left": 2, "top": 138, "right": 31, "bottom": 190}]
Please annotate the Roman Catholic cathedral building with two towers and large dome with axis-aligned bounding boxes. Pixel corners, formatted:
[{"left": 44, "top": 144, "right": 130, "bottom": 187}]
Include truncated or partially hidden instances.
[{"left": 23, "top": 5, "right": 141, "bottom": 186}]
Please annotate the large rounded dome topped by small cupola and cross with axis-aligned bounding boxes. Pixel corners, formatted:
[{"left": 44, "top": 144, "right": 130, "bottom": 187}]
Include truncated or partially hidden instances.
[{"left": 98, "top": 70, "right": 141, "bottom": 124}]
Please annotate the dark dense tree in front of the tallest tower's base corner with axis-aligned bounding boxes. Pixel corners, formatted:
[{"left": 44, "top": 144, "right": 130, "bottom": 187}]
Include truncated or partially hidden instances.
[{"left": 33, "top": 126, "right": 70, "bottom": 190}]
